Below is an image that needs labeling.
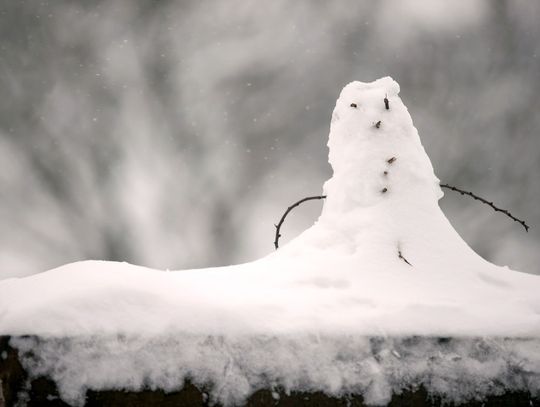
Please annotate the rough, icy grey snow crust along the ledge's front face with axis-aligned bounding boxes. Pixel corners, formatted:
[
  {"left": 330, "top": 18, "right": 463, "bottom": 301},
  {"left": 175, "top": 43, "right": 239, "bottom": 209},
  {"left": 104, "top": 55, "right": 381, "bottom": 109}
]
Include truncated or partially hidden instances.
[{"left": 12, "top": 334, "right": 540, "bottom": 405}]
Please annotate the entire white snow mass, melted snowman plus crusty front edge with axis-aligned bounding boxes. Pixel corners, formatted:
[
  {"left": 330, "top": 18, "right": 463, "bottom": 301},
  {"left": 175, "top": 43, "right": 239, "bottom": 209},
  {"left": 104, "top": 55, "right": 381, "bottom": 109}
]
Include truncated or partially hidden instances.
[{"left": 0, "top": 77, "right": 540, "bottom": 405}]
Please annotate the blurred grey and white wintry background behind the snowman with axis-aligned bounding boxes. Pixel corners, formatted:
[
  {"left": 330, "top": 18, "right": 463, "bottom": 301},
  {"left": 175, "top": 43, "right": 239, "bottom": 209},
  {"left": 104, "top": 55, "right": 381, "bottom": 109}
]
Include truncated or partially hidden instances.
[{"left": 0, "top": 0, "right": 540, "bottom": 278}]
